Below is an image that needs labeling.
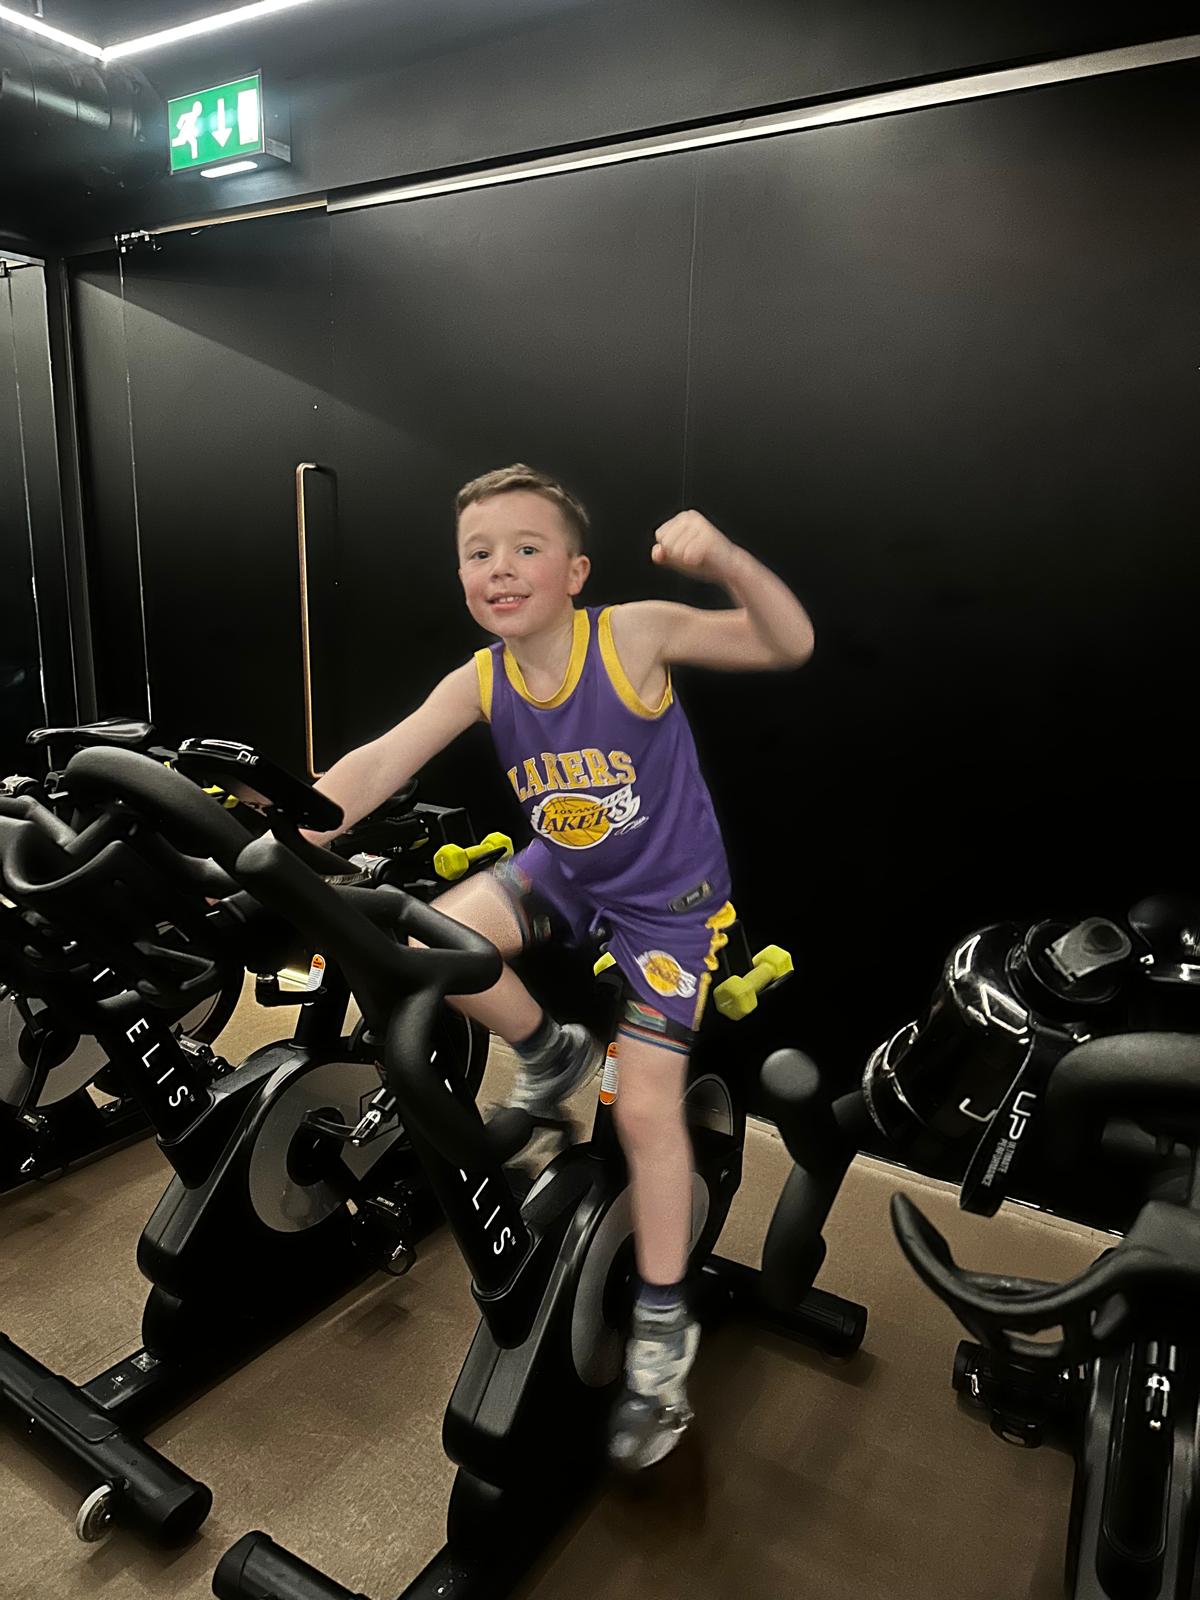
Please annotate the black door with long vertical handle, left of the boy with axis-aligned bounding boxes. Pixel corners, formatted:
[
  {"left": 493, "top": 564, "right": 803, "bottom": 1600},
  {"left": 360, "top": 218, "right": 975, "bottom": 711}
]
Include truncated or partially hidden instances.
[{"left": 74, "top": 211, "right": 333, "bottom": 768}]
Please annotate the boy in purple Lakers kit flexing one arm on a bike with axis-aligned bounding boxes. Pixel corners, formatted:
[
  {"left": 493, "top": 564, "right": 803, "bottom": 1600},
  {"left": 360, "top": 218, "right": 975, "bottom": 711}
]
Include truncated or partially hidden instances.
[{"left": 310, "top": 466, "right": 813, "bottom": 1467}]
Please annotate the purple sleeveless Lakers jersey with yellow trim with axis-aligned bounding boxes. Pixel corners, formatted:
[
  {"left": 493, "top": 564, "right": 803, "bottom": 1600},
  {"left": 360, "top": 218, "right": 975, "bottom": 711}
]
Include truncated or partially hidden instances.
[{"left": 475, "top": 606, "right": 730, "bottom": 912}]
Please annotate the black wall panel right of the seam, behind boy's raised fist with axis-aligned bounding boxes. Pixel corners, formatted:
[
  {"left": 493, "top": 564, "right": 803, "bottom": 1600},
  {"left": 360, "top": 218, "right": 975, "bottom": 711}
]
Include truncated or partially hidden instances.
[{"left": 688, "top": 66, "right": 1200, "bottom": 1067}]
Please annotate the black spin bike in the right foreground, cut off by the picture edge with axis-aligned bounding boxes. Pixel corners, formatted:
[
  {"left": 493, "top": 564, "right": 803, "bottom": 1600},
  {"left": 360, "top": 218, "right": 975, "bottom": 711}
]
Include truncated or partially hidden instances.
[{"left": 891, "top": 1034, "right": 1200, "bottom": 1600}]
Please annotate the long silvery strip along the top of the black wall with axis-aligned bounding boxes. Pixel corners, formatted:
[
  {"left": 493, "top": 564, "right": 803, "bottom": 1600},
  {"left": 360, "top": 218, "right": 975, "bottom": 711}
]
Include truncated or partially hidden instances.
[{"left": 330, "top": 34, "right": 1200, "bottom": 211}]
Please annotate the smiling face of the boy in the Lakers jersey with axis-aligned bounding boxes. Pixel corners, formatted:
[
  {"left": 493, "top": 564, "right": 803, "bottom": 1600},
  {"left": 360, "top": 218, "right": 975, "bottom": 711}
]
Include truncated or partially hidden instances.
[{"left": 458, "top": 490, "right": 592, "bottom": 640}]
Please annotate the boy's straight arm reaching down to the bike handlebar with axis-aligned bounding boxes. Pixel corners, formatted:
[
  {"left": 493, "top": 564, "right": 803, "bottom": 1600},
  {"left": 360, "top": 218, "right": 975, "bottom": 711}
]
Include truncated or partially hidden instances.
[{"left": 302, "top": 661, "right": 483, "bottom": 845}]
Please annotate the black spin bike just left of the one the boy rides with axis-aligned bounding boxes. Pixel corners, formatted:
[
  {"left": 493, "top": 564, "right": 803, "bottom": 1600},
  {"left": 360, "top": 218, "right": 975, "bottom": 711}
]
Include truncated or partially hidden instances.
[{"left": 0, "top": 749, "right": 486, "bottom": 1544}]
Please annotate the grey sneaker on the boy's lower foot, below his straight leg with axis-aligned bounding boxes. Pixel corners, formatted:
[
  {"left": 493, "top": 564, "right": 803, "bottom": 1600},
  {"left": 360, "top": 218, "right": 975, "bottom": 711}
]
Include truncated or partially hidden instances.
[{"left": 608, "top": 1307, "right": 699, "bottom": 1472}]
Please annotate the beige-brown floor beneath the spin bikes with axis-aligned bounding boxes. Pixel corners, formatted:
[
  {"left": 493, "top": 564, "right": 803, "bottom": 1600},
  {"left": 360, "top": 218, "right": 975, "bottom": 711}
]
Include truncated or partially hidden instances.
[{"left": 0, "top": 985, "right": 1099, "bottom": 1600}]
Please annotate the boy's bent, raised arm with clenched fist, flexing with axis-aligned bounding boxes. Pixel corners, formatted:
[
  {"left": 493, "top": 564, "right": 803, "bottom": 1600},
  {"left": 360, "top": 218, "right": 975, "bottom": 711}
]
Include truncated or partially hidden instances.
[{"left": 613, "top": 510, "right": 813, "bottom": 682}]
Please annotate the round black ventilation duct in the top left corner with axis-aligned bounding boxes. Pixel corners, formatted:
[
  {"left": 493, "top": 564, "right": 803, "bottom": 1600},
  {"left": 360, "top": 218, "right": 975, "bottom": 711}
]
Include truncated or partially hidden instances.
[{"left": 0, "top": 24, "right": 166, "bottom": 205}]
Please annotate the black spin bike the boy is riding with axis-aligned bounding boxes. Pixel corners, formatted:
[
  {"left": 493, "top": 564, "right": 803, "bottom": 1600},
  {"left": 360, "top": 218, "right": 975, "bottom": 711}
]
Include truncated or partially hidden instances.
[{"left": 202, "top": 755, "right": 866, "bottom": 1600}]
